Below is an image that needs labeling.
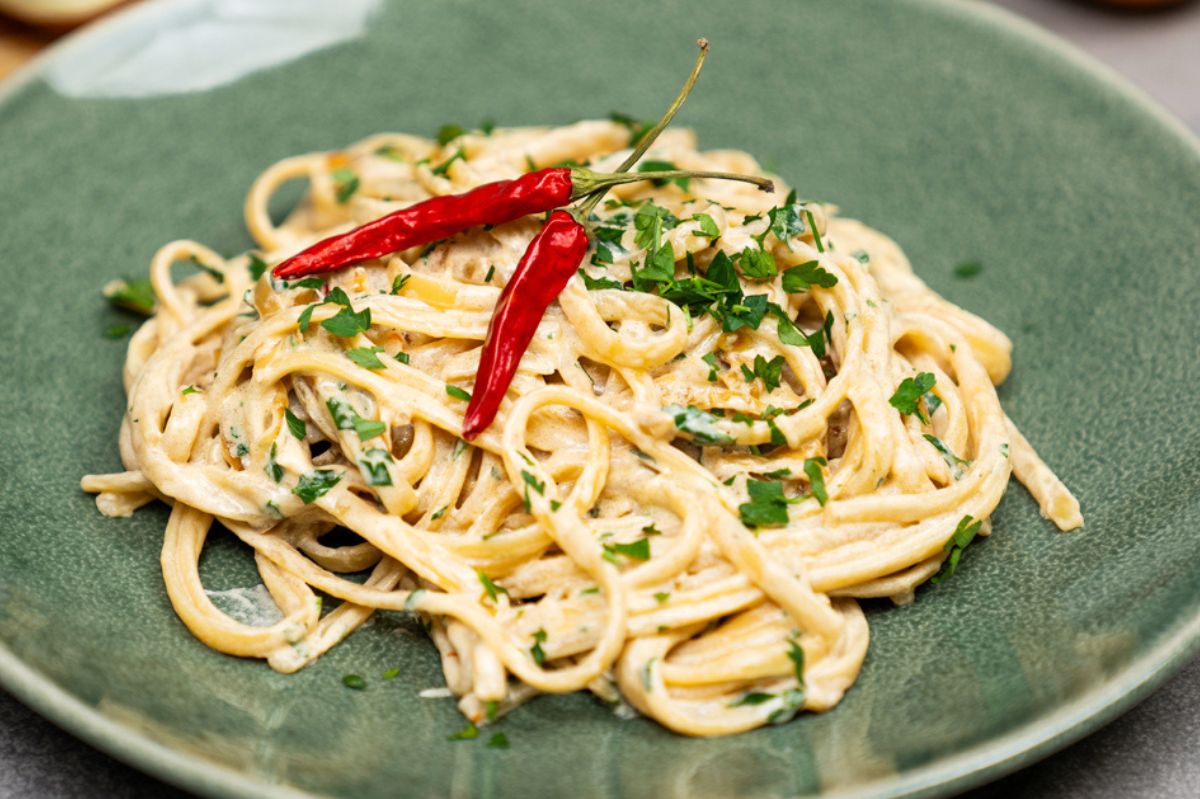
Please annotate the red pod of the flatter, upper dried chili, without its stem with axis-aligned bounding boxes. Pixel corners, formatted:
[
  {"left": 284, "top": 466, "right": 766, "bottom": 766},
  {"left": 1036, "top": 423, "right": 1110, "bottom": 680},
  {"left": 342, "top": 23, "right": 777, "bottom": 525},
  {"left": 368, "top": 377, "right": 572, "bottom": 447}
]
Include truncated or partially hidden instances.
[{"left": 271, "top": 167, "right": 575, "bottom": 280}]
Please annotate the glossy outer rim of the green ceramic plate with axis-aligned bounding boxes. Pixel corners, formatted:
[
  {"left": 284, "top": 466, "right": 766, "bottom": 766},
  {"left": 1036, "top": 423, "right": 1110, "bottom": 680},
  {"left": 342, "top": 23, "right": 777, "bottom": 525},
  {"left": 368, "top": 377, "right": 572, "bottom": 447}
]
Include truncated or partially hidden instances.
[{"left": 0, "top": 0, "right": 1200, "bottom": 799}]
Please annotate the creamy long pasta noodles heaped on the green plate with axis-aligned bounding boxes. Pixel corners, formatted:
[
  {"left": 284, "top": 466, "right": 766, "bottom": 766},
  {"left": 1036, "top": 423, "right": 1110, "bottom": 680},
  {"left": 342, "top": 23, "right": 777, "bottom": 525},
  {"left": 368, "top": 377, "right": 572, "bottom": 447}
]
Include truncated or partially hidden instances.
[{"left": 83, "top": 121, "right": 1082, "bottom": 735}]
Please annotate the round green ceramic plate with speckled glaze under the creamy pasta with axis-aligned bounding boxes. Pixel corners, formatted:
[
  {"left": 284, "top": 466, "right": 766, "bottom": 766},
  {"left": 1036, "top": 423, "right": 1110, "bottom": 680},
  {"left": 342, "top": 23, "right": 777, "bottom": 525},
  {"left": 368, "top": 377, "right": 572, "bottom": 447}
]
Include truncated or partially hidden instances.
[{"left": 0, "top": 0, "right": 1200, "bottom": 797}]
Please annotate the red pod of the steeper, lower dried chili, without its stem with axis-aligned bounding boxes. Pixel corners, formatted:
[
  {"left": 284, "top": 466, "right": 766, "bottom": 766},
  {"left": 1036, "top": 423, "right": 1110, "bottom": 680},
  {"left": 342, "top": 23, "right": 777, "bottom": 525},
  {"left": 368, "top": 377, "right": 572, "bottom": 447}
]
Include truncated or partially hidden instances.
[{"left": 462, "top": 211, "right": 588, "bottom": 440}]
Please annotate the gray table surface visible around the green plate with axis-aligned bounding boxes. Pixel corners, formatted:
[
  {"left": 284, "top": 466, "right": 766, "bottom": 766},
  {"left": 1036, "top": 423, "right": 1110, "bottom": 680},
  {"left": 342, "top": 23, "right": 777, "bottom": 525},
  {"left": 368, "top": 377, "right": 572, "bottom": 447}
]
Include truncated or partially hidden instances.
[{"left": 0, "top": 0, "right": 1200, "bottom": 799}]
